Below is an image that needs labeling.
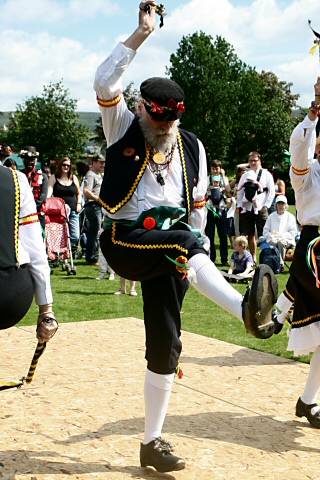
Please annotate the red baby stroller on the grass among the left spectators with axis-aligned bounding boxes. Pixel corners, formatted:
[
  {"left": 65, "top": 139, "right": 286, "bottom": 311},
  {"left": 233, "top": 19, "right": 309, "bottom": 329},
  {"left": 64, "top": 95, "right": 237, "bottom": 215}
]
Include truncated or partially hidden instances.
[{"left": 44, "top": 197, "right": 76, "bottom": 275}]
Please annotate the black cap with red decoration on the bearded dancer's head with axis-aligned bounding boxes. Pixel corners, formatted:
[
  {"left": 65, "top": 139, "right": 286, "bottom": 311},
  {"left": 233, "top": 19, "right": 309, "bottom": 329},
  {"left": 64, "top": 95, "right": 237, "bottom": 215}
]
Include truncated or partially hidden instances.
[{"left": 140, "top": 77, "right": 185, "bottom": 121}]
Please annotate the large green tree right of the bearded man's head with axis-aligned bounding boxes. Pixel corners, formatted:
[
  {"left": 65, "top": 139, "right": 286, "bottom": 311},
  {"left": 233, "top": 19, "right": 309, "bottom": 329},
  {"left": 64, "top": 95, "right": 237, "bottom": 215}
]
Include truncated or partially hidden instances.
[{"left": 167, "top": 32, "right": 297, "bottom": 172}]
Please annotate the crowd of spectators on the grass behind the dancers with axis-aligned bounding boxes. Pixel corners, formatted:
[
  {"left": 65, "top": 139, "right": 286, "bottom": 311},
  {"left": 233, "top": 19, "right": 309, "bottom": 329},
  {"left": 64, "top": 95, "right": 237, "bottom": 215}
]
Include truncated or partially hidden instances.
[{"left": 0, "top": 141, "right": 299, "bottom": 286}]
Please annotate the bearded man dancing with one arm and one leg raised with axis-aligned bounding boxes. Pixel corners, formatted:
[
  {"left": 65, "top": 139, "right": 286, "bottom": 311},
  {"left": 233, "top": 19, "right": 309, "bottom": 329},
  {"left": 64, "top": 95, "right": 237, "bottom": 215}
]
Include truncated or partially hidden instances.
[{"left": 94, "top": 1, "right": 275, "bottom": 472}]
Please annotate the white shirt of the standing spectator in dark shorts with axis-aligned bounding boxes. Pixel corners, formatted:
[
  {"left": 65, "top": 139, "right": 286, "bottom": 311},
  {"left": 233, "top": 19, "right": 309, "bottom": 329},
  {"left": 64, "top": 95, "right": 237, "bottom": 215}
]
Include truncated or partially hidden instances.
[{"left": 237, "top": 168, "right": 275, "bottom": 213}]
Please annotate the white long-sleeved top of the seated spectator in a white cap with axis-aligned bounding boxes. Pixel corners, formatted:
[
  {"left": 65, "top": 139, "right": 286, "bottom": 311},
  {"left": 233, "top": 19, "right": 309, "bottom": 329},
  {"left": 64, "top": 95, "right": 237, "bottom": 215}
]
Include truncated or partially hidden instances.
[{"left": 263, "top": 212, "right": 298, "bottom": 246}]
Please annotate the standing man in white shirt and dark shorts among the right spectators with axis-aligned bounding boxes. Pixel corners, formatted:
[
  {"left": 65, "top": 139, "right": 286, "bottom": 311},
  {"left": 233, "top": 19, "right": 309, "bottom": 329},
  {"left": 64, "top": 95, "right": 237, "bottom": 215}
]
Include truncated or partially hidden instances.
[{"left": 237, "top": 152, "right": 275, "bottom": 262}]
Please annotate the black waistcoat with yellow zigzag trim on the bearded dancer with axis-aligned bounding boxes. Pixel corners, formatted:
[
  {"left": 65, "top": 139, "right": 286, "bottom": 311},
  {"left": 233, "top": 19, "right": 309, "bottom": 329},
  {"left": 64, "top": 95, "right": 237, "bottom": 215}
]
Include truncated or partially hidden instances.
[{"left": 100, "top": 117, "right": 199, "bottom": 215}]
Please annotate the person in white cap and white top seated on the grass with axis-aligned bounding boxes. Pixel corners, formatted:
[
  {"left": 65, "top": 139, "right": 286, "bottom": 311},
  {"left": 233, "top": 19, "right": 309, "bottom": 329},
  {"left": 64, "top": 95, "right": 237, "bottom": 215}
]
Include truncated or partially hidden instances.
[{"left": 263, "top": 195, "right": 298, "bottom": 269}]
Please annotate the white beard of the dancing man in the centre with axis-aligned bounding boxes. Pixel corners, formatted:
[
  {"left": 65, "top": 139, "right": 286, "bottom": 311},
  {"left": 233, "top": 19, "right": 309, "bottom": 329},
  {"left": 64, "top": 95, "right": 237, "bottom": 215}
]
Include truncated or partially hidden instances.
[{"left": 139, "top": 116, "right": 179, "bottom": 153}]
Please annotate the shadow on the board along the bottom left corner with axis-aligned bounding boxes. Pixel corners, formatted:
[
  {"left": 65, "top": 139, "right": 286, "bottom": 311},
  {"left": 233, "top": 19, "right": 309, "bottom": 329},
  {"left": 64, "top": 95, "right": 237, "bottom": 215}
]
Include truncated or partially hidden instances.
[{"left": 0, "top": 450, "right": 175, "bottom": 480}]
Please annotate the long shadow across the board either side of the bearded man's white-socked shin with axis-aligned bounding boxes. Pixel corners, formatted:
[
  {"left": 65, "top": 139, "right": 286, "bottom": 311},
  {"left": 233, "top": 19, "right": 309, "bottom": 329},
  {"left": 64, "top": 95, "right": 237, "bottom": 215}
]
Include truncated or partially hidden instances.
[{"left": 55, "top": 411, "right": 320, "bottom": 453}]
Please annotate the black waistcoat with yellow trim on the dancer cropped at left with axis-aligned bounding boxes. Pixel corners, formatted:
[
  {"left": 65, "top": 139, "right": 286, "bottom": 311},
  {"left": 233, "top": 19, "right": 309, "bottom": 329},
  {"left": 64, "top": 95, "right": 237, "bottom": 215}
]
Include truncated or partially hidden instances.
[{"left": 0, "top": 166, "right": 20, "bottom": 269}]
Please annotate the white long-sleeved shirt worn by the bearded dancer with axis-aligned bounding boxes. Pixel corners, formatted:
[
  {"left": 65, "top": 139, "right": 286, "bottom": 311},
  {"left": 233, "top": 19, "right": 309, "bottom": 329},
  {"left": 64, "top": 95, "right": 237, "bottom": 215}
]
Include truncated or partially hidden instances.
[{"left": 94, "top": 43, "right": 207, "bottom": 232}]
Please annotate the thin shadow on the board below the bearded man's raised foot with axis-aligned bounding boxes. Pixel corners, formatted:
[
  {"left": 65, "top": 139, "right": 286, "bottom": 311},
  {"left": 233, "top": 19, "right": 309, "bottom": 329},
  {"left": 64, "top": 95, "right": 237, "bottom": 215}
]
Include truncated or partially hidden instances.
[{"left": 180, "top": 348, "right": 295, "bottom": 367}]
